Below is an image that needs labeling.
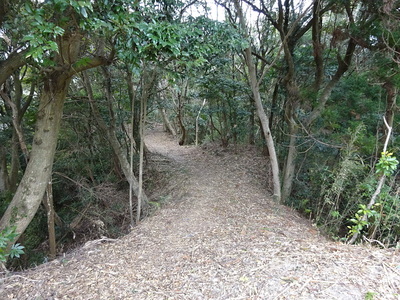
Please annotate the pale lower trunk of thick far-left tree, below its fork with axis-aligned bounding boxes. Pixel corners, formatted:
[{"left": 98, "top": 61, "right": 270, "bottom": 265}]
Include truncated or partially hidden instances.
[{"left": 0, "top": 73, "right": 70, "bottom": 241}]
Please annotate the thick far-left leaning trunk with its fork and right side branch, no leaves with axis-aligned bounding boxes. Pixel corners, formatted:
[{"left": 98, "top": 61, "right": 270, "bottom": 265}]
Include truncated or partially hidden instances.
[{"left": 0, "top": 28, "right": 114, "bottom": 244}]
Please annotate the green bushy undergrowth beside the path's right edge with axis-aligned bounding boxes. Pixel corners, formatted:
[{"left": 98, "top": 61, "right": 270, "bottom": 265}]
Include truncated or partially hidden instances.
[{"left": 292, "top": 124, "right": 400, "bottom": 247}]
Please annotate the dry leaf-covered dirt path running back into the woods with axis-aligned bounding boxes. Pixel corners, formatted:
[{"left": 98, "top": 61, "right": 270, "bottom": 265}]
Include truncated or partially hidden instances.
[{"left": 0, "top": 125, "right": 400, "bottom": 300}]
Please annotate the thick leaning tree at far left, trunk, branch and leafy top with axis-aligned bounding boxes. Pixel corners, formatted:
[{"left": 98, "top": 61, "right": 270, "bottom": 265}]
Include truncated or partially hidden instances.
[{"left": 0, "top": 1, "right": 112, "bottom": 246}]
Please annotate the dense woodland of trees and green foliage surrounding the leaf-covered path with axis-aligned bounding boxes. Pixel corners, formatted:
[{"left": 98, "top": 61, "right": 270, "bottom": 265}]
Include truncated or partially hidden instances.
[{"left": 0, "top": 0, "right": 400, "bottom": 267}]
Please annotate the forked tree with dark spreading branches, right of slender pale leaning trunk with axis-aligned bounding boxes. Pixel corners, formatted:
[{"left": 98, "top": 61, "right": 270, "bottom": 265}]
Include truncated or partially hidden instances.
[{"left": 244, "top": 0, "right": 366, "bottom": 201}]
